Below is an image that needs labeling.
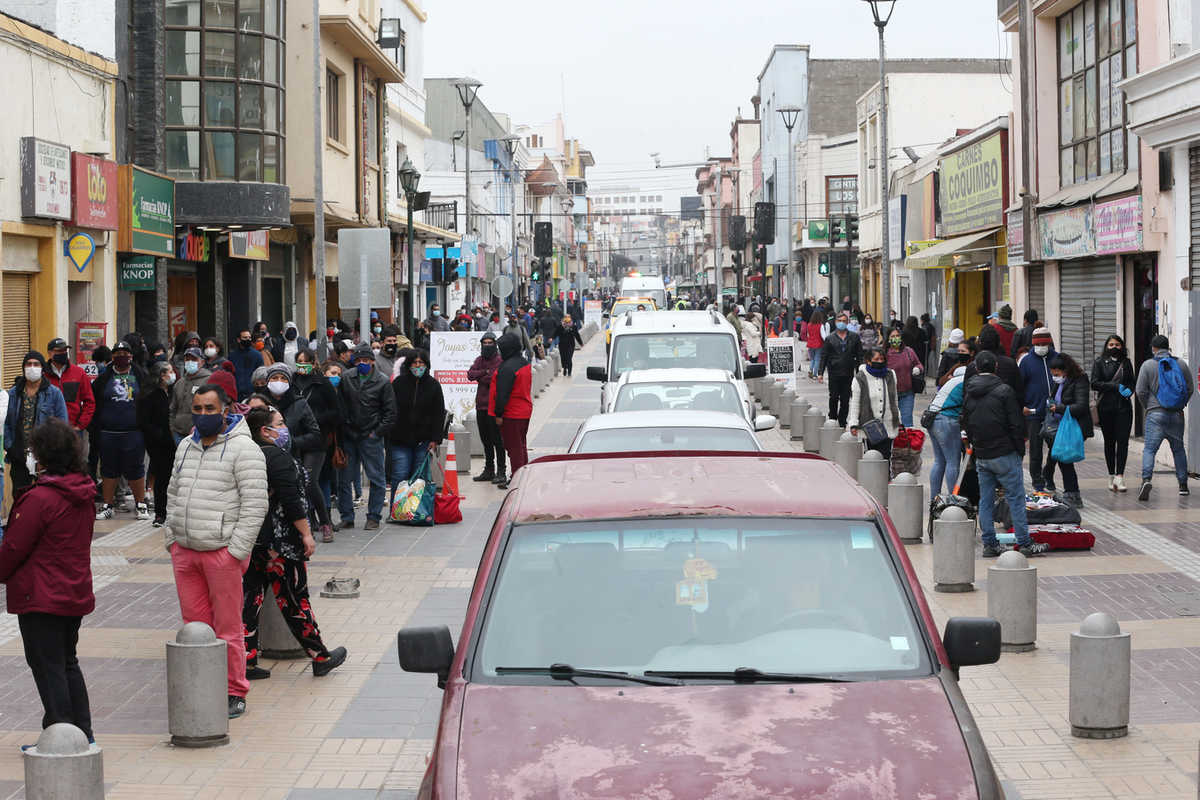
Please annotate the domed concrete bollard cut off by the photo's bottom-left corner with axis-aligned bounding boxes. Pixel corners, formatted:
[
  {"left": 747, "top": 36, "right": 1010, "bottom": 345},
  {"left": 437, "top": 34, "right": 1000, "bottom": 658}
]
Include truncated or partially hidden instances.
[{"left": 22, "top": 724, "right": 102, "bottom": 800}]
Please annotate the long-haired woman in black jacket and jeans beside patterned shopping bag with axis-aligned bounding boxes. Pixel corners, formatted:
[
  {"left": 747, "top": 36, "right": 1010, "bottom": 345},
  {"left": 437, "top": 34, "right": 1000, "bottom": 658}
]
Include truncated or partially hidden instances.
[{"left": 388, "top": 350, "right": 446, "bottom": 504}]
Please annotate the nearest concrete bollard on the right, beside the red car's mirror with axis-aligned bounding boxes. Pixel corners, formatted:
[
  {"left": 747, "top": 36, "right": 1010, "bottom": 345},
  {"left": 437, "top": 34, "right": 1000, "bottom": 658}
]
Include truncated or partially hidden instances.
[{"left": 1068, "top": 613, "right": 1130, "bottom": 739}]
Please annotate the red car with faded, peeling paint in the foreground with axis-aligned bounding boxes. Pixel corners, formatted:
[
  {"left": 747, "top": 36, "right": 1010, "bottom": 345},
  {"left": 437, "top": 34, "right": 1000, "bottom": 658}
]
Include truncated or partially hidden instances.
[{"left": 398, "top": 452, "right": 1003, "bottom": 800}]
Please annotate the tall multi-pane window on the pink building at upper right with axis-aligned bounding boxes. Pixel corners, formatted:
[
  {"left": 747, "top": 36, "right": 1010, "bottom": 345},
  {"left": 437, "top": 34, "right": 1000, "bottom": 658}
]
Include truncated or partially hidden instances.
[{"left": 1058, "top": 0, "right": 1138, "bottom": 186}]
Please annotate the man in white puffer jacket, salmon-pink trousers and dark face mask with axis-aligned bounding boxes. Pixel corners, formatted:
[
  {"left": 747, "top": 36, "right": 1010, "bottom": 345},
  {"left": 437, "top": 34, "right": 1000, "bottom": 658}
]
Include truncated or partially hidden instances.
[{"left": 164, "top": 384, "right": 268, "bottom": 718}]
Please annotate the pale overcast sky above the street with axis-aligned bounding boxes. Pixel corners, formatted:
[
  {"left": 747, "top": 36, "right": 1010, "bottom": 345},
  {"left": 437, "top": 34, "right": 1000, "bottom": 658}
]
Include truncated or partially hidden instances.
[{"left": 425, "top": 0, "right": 1010, "bottom": 194}]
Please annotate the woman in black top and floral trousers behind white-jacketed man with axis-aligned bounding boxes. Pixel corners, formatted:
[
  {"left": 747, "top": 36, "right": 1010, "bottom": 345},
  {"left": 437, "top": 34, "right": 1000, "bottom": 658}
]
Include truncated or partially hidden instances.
[{"left": 241, "top": 409, "right": 346, "bottom": 680}]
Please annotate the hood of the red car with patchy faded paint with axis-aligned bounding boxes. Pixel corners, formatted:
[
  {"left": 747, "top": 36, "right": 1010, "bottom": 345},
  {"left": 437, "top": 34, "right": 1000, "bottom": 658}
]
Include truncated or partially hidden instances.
[{"left": 457, "top": 678, "right": 978, "bottom": 800}]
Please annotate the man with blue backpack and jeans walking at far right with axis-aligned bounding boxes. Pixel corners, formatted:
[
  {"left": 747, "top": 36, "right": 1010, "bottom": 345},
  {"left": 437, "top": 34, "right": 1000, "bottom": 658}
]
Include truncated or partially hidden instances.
[{"left": 1132, "top": 333, "right": 1195, "bottom": 501}]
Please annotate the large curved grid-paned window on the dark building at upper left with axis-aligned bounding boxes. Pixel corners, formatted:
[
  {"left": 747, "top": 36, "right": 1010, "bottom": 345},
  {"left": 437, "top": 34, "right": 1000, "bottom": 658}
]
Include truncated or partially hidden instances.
[{"left": 164, "top": 0, "right": 286, "bottom": 182}]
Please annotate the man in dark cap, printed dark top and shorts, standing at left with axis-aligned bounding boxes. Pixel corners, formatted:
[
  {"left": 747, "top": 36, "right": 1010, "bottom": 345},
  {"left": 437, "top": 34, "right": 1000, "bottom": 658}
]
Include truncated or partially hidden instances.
[{"left": 92, "top": 342, "right": 150, "bottom": 519}]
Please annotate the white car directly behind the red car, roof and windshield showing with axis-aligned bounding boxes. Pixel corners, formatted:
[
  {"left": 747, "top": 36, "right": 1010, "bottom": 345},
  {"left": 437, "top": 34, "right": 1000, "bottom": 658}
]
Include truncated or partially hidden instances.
[{"left": 568, "top": 411, "right": 774, "bottom": 453}]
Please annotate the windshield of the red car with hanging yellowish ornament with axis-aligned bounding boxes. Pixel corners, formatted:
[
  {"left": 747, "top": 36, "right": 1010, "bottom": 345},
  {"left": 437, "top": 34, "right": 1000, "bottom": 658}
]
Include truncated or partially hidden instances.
[{"left": 472, "top": 517, "right": 931, "bottom": 682}]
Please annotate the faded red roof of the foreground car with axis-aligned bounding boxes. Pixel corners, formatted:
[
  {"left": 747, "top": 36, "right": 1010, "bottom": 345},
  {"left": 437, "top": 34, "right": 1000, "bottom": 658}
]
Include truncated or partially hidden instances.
[{"left": 511, "top": 453, "right": 878, "bottom": 522}]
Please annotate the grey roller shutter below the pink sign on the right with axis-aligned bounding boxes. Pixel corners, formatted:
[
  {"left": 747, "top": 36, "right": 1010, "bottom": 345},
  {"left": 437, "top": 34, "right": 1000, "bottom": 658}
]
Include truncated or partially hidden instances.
[{"left": 1057, "top": 258, "right": 1117, "bottom": 372}]
